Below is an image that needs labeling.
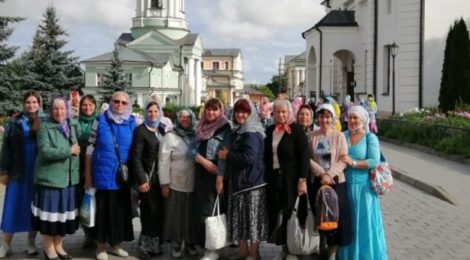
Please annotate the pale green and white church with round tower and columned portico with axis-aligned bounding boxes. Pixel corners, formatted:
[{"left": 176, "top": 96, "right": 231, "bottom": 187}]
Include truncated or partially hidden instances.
[{"left": 82, "top": 0, "right": 205, "bottom": 106}]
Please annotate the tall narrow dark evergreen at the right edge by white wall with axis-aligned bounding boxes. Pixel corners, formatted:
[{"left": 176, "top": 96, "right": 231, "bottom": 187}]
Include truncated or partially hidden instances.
[{"left": 439, "top": 19, "right": 470, "bottom": 112}]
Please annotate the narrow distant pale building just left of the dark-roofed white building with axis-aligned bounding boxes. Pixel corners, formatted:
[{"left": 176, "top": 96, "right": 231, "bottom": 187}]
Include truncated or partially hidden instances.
[{"left": 284, "top": 52, "right": 306, "bottom": 97}]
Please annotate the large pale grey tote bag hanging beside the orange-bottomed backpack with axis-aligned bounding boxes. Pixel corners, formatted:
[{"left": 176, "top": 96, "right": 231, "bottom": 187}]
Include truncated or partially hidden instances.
[{"left": 287, "top": 196, "right": 320, "bottom": 255}]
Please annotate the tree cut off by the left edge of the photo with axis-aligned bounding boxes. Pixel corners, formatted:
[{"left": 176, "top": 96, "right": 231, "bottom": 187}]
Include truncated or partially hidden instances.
[{"left": 0, "top": 1, "right": 24, "bottom": 113}]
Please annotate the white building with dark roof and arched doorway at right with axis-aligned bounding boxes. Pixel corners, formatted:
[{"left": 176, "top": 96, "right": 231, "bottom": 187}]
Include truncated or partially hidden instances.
[{"left": 302, "top": 0, "right": 425, "bottom": 112}]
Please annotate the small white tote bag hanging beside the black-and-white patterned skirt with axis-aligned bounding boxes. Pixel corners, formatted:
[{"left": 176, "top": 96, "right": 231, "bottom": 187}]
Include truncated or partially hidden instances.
[{"left": 205, "top": 195, "right": 227, "bottom": 250}]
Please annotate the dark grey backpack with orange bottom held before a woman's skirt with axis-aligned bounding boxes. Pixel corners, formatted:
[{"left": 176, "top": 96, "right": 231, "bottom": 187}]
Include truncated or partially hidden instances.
[{"left": 315, "top": 185, "right": 339, "bottom": 231}]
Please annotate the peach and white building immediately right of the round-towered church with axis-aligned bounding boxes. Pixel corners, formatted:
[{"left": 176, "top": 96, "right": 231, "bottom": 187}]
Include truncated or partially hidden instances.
[{"left": 201, "top": 49, "right": 244, "bottom": 106}]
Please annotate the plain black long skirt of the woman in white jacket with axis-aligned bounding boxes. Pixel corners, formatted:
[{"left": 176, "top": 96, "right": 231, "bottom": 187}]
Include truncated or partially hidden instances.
[{"left": 163, "top": 189, "right": 195, "bottom": 244}]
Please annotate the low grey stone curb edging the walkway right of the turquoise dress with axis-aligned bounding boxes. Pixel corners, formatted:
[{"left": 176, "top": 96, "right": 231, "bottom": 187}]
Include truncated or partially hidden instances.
[{"left": 392, "top": 166, "right": 458, "bottom": 206}]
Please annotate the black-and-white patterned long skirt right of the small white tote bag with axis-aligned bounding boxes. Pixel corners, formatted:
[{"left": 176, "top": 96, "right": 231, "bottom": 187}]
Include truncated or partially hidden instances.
[{"left": 229, "top": 187, "right": 268, "bottom": 242}]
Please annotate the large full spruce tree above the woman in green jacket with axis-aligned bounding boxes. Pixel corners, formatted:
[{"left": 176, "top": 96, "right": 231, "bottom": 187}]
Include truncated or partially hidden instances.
[{"left": 23, "top": 6, "right": 83, "bottom": 106}]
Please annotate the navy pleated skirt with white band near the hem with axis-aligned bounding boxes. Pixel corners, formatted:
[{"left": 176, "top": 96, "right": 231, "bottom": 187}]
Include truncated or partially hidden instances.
[{"left": 31, "top": 185, "right": 78, "bottom": 236}]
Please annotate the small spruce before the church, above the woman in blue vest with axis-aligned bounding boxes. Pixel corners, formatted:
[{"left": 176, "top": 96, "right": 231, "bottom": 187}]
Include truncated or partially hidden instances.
[{"left": 99, "top": 47, "right": 132, "bottom": 103}]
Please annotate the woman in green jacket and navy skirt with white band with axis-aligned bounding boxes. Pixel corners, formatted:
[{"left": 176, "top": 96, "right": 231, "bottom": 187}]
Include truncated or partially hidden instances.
[{"left": 31, "top": 97, "right": 80, "bottom": 259}]
